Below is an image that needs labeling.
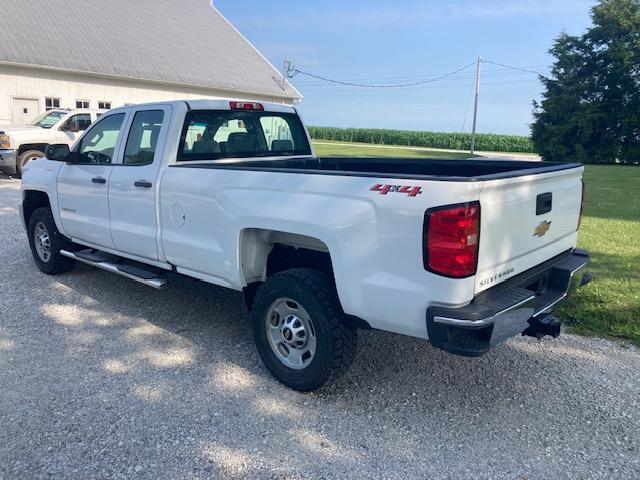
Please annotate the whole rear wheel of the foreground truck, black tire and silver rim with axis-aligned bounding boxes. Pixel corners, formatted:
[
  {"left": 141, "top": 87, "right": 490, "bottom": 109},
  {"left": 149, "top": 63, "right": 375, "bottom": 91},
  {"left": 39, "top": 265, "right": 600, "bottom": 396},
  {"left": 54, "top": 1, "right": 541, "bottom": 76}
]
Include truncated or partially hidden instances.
[{"left": 252, "top": 268, "right": 357, "bottom": 392}]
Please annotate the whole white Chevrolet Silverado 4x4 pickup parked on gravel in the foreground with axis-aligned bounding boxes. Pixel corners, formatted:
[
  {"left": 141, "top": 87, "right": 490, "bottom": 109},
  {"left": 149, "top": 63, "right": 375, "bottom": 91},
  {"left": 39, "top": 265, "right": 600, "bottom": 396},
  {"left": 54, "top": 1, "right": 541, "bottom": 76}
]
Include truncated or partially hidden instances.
[{"left": 21, "top": 100, "right": 590, "bottom": 391}]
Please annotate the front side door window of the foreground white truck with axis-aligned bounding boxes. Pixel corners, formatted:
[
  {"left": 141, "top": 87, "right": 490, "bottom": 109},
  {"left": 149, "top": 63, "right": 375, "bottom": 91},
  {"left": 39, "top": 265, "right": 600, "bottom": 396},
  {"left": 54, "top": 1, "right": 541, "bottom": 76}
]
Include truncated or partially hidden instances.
[{"left": 76, "top": 113, "right": 124, "bottom": 164}]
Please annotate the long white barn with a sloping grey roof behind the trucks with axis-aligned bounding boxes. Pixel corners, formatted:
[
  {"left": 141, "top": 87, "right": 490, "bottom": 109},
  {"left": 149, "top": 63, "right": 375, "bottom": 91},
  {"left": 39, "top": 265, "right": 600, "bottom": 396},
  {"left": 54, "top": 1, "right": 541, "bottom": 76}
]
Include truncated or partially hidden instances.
[{"left": 0, "top": 0, "right": 302, "bottom": 125}]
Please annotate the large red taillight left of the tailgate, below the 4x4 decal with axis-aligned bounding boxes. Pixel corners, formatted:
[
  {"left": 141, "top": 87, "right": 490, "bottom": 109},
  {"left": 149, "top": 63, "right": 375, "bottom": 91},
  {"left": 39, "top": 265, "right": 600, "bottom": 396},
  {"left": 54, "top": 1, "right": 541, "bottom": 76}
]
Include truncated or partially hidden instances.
[{"left": 424, "top": 202, "right": 480, "bottom": 278}]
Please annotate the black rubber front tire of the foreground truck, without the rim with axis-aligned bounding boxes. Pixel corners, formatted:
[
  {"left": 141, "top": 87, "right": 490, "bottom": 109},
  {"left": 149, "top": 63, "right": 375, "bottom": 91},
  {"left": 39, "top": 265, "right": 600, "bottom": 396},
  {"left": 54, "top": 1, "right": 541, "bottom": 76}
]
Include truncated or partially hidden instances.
[{"left": 27, "top": 207, "right": 76, "bottom": 275}]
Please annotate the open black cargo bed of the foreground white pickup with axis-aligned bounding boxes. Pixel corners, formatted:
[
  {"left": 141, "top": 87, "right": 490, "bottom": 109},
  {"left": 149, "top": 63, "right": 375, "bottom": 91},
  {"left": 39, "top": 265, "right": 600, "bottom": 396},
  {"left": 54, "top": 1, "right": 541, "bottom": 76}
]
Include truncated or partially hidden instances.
[{"left": 175, "top": 157, "right": 580, "bottom": 182}]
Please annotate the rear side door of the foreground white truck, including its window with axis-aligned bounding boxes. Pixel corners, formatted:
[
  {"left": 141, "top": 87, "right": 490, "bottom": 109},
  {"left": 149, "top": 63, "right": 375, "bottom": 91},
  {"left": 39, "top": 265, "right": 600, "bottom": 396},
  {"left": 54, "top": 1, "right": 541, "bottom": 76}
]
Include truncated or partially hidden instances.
[{"left": 109, "top": 106, "right": 171, "bottom": 260}]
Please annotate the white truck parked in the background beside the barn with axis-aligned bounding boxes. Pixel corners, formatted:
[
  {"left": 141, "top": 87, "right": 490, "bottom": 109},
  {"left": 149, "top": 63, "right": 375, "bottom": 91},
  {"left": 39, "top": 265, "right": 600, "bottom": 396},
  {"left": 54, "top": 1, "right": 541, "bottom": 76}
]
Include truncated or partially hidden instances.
[{"left": 0, "top": 108, "right": 106, "bottom": 177}]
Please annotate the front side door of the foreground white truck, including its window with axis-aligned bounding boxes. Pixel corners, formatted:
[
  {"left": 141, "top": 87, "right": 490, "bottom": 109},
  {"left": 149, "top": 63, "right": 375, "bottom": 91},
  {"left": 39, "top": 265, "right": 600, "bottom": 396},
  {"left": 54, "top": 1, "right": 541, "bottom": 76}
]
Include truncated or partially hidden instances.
[{"left": 58, "top": 113, "right": 125, "bottom": 248}]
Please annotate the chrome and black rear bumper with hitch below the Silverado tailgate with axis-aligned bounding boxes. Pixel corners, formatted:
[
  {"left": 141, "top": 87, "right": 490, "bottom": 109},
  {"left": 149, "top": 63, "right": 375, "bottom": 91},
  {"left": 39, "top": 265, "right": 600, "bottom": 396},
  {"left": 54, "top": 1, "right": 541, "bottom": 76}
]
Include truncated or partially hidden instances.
[{"left": 427, "top": 249, "right": 591, "bottom": 356}]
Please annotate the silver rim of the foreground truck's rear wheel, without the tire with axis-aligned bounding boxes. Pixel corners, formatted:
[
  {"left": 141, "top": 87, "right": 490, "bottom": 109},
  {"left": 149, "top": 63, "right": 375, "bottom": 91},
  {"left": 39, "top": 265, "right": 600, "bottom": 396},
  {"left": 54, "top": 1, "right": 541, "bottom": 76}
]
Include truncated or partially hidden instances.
[{"left": 265, "top": 298, "right": 317, "bottom": 370}]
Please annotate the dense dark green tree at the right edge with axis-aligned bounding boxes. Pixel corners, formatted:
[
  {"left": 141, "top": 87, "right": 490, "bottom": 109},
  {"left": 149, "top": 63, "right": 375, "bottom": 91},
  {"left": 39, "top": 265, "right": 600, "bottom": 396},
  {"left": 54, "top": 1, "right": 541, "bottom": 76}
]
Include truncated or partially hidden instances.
[{"left": 531, "top": 0, "right": 640, "bottom": 165}]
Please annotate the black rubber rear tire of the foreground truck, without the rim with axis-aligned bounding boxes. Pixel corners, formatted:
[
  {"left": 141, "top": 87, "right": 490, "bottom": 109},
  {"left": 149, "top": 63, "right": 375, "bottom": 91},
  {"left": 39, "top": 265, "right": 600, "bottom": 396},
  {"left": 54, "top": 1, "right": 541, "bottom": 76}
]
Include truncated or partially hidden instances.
[{"left": 251, "top": 268, "right": 357, "bottom": 392}]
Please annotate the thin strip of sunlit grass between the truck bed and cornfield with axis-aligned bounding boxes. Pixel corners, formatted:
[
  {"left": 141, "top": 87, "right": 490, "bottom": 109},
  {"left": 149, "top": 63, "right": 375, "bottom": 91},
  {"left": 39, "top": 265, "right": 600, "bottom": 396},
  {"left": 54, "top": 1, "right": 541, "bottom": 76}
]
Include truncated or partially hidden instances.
[{"left": 313, "top": 142, "right": 475, "bottom": 160}]
